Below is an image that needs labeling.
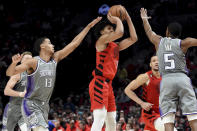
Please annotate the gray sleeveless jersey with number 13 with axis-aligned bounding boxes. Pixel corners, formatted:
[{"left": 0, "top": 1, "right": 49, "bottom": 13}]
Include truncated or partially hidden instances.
[{"left": 25, "top": 56, "right": 57, "bottom": 103}]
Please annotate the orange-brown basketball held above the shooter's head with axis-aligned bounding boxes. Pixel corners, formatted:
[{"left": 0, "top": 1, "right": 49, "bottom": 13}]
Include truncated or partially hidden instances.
[{"left": 108, "top": 5, "right": 126, "bottom": 21}]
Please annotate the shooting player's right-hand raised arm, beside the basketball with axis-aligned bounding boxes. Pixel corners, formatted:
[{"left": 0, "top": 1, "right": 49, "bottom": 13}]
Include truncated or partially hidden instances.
[{"left": 119, "top": 9, "right": 138, "bottom": 51}]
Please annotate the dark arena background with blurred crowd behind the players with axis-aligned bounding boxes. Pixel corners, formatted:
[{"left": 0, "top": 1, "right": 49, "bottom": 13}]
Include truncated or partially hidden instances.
[{"left": 0, "top": 0, "right": 197, "bottom": 131}]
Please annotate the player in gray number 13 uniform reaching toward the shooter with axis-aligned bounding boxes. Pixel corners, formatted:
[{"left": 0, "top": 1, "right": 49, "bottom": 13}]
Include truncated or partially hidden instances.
[{"left": 6, "top": 17, "right": 101, "bottom": 131}]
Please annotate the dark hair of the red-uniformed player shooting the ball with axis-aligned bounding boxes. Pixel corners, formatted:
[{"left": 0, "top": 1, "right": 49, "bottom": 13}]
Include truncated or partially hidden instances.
[{"left": 94, "top": 18, "right": 115, "bottom": 39}]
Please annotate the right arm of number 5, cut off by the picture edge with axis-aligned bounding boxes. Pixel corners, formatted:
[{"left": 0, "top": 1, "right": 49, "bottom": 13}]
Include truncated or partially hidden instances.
[{"left": 180, "top": 37, "right": 197, "bottom": 53}]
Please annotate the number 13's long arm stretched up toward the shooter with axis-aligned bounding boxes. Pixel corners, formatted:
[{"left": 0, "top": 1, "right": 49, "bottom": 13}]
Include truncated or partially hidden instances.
[{"left": 54, "top": 17, "right": 102, "bottom": 62}]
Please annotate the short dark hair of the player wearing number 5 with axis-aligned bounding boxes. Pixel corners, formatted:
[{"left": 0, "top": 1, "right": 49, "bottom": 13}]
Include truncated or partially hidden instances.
[{"left": 168, "top": 22, "right": 182, "bottom": 38}]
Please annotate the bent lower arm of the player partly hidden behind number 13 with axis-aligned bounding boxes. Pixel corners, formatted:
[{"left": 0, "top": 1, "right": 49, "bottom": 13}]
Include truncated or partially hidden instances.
[{"left": 4, "top": 74, "right": 26, "bottom": 97}]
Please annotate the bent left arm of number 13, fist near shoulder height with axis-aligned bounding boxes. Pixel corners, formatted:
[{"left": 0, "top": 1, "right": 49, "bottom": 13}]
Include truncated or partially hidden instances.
[{"left": 6, "top": 54, "right": 37, "bottom": 76}]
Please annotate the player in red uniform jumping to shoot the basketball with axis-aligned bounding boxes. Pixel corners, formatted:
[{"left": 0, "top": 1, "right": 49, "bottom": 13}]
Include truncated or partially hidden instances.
[{"left": 89, "top": 5, "right": 137, "bottom": 131}]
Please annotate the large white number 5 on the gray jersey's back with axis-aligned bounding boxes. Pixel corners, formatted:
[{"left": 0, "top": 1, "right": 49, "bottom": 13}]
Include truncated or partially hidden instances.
[{"left": 164, "top": 53, "right": 175, "bottom": 70}]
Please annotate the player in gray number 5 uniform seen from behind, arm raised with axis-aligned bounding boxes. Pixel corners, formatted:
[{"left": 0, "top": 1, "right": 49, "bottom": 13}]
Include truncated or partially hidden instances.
[{"left": 140, "top": 8, "right": 197, "bottom": 131}]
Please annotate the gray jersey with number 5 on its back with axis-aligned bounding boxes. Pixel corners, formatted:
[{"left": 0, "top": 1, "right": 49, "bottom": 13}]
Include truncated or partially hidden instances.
[{"left": 157, "top": 37, "right": 187, "bottom": 75}]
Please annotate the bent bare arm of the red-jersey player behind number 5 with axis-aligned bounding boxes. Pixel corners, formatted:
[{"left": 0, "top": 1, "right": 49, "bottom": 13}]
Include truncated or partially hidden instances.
[{"left": 124, "top": 73, "right": 153, "bottom": 111}]
